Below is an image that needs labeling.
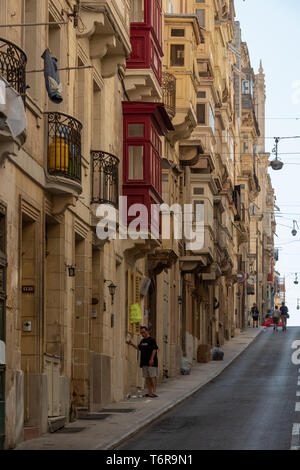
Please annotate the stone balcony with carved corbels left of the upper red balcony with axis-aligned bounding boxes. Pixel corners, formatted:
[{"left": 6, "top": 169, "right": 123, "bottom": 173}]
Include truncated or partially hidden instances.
[{"left": 78, "top": 0, "right": 131, "bottom": 78}]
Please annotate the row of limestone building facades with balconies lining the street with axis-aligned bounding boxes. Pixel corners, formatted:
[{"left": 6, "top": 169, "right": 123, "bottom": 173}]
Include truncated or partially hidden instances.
[{"left": 0, "top": 0, "right": 275, "bottom": 449}]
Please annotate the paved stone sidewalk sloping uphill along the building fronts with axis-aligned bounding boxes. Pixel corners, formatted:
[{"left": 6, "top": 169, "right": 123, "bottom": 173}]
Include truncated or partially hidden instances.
[{"left": 16, "top": 328, "right": 262, "bottom": 450}]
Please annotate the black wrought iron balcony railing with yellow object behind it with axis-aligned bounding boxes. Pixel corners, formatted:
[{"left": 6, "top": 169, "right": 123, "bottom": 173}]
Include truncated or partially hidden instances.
[{"left": 45, "top": 112, "right": 82, "bottom": 183}]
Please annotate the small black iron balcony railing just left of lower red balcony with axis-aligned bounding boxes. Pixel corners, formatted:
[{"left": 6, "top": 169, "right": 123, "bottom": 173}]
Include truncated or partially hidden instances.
[{"left": 91, "top": 150, "right": 119, "bottom": 207}]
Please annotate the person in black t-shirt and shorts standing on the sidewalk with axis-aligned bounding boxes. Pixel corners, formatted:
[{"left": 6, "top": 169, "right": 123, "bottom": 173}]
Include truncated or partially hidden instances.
[{"left": 128, "top": 326, "right": 158, "bottom": 398}]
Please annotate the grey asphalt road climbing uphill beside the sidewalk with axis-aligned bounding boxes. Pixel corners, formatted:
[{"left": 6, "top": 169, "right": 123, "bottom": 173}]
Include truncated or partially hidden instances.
[{"left": 119, "top": 327, "right": 300, "bottom": 450}]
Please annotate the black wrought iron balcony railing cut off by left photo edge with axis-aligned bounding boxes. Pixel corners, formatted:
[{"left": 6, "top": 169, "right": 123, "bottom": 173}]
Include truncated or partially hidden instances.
[{"left": 0, "top": 38, "right": 27, "bottom": 103}]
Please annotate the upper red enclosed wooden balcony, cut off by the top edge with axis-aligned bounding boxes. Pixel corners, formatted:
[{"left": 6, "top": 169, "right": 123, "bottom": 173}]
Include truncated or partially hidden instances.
[{"left": 126, "top": 0, "right": 163, "bottom": 85}]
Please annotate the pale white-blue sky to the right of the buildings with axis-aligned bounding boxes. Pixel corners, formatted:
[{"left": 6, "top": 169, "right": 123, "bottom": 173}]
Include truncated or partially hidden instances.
[{"left": 235, "top": 0, "right": 300, "bottom": 326}]
